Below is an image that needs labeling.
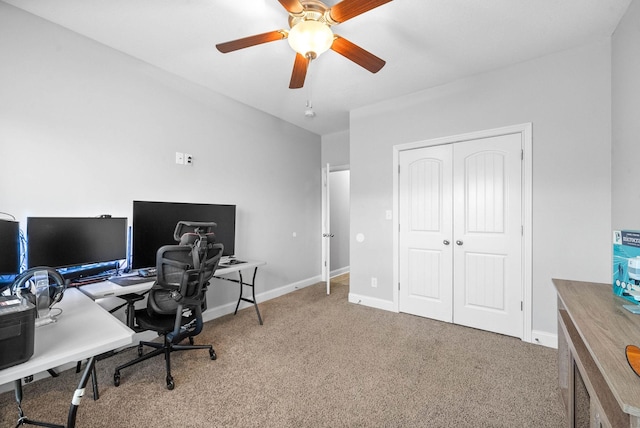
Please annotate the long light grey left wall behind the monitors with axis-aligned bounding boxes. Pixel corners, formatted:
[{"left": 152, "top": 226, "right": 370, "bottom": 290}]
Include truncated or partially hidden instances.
[{"left": 0, "top": 2, "right": 321, "bottom": 307}]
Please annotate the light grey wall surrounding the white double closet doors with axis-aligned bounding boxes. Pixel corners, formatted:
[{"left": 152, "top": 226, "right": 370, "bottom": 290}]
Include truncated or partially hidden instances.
[{"left": 350, "top": 39, "right": 611, "bottom": 339}]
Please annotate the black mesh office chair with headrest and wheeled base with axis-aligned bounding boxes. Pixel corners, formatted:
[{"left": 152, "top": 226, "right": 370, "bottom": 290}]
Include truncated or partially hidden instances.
[{"left": 113, "top": 221, "right": 223, "bottom": 390}]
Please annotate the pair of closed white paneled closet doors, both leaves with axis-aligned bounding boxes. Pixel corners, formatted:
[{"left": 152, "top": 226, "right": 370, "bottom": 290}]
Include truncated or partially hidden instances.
[{"left": 399, "top": 134, "right": 523, "bottom": 338}]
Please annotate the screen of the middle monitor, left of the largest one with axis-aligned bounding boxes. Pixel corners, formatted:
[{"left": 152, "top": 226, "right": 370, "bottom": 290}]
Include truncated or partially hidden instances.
[{"left": 27, "top": 217, "right": 127, "bottom": 268}]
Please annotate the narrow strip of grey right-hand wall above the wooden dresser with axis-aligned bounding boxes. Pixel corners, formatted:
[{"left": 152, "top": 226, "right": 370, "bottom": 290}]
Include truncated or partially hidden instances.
[{"left": 612, "top": 0, "right": 640, "bottom": 230}]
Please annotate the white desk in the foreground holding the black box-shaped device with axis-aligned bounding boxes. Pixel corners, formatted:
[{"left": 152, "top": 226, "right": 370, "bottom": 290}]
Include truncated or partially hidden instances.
[{"left": 0, "top": 288, "right": 133, "bottom": 427}]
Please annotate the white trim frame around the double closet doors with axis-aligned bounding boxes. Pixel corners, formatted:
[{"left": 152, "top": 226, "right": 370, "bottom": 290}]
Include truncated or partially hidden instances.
[{"left": 393, "top": 122, "right": 533, "bottom": 342}]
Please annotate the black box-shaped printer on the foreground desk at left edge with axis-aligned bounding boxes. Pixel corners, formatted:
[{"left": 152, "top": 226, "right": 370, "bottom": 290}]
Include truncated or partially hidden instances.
[{"left": 0, "top": 296, "right": 36, "bottom": 370}]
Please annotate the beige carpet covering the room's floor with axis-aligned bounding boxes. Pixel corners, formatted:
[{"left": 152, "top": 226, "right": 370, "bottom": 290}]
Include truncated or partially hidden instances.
[{"left": 0, "top": 276, "right": 566, "bottom": 428}]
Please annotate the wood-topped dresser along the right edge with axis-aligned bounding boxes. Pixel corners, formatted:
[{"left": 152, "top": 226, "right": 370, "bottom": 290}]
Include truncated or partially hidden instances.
[{"left": 553, "top": 279, "right": 640, "bottom": 428}]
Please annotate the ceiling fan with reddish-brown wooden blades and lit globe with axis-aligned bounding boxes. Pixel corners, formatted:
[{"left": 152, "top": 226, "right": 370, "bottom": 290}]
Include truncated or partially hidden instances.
[{"left": 216, "top": 0, "right": 392, "bottom": 89}]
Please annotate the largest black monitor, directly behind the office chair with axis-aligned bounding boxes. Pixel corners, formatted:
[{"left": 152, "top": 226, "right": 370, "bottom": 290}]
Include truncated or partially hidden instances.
[{"left": 132, "top": 201, "right": 236, "bottom": 269}]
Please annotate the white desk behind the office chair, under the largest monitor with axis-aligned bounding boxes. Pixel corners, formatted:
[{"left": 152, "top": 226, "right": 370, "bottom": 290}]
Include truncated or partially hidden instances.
[{"left": 78, "top": 260, "right": 267, "bottom": 325}]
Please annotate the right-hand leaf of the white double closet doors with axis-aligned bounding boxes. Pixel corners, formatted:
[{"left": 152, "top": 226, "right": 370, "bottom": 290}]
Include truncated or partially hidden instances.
[{"left": 453, "top": 134, "right": 523, "bottom": 337}]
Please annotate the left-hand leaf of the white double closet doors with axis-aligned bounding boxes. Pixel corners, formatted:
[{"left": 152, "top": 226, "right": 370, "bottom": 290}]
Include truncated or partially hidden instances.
[{"left": 399, "top": 145, "right": 453, "bottom": 322}]
